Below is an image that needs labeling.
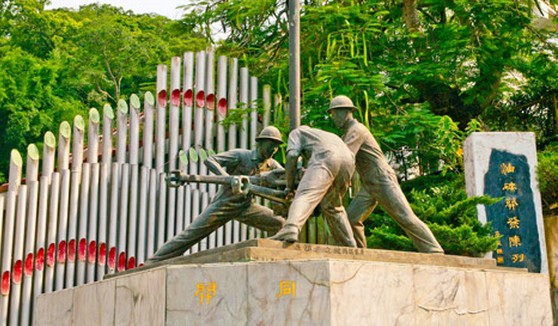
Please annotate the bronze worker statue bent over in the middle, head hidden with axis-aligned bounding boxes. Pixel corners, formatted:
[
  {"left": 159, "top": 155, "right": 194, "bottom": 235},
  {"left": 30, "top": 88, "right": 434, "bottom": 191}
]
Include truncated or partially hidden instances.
[{"left": 270, "top": 126, "right": 356, "bottom": 247}]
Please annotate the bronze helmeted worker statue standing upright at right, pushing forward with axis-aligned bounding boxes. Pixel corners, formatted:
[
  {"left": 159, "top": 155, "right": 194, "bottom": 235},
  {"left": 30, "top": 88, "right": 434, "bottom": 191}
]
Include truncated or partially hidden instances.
[{"left": 327, "top": 95, "right": 444, "bottom": 253}]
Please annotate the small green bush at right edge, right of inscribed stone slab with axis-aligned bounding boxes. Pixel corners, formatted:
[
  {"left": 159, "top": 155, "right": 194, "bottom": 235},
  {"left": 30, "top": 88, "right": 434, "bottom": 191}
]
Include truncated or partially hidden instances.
[{"left": 537, "top": 143, "right": 558, "bottom": 215}]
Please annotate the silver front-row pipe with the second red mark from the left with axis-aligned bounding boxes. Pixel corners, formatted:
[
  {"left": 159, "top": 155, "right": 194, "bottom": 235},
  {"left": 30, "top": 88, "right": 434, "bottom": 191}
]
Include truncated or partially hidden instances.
[{"left": 9, "top": 185, "right": 27, "bottom": 326}]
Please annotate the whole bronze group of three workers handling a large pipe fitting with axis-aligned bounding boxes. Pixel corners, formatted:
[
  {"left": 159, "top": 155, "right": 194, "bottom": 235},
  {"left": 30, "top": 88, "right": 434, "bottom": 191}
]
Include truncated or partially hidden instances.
[{"left": 146, "top": 95, "right": 444, "bottom": 264}]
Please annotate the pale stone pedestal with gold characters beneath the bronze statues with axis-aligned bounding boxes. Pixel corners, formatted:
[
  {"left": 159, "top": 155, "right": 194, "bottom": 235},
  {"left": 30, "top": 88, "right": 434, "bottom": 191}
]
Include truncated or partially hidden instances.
[{"left": 34, "top": 240, "right": 552, "bottom": 325}]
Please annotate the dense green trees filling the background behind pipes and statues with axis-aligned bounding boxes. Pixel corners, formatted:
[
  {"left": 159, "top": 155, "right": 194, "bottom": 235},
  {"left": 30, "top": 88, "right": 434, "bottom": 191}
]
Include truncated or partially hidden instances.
[{"left": 0, "top": 0, "right": 558, "bottom": 255}]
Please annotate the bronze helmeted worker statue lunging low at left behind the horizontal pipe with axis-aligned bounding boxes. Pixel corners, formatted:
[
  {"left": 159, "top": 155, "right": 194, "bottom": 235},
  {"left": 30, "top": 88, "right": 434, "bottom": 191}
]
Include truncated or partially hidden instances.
[{"left": 146, "top": 126, "right": 285, "bottom": 265}]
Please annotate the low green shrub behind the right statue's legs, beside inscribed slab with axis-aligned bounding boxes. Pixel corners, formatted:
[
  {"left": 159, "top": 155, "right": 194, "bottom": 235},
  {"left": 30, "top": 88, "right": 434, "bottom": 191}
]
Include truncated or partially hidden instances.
[{"left": 366, "top": 173, "right": 501, "bottom": 257}]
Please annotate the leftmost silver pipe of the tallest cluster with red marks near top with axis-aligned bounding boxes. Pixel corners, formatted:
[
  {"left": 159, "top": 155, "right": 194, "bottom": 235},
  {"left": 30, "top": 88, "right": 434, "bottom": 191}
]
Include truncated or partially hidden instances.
[{"left": 155, "top": 65, "right": 167, "bottom": 173}]
